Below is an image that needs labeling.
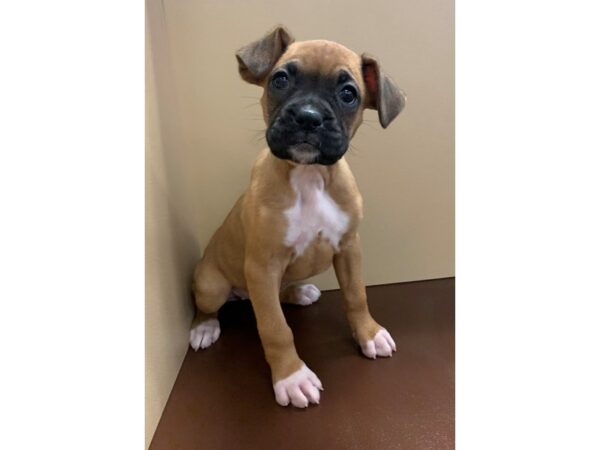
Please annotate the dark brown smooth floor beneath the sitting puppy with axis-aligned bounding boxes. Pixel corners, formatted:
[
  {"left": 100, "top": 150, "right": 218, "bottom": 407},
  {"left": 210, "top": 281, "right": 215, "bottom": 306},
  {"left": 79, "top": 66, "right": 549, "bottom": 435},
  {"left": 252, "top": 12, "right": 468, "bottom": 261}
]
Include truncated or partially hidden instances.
[{"left": 150, "top": 278, "right": 454, "bottom": 450}]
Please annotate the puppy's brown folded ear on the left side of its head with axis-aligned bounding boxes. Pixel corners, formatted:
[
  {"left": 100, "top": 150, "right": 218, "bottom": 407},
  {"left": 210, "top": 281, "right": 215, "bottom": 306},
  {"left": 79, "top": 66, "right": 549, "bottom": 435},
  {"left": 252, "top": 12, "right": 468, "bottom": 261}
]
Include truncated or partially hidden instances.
[{"left": 235, "top": 26, "right": 294, "bottom": 84}]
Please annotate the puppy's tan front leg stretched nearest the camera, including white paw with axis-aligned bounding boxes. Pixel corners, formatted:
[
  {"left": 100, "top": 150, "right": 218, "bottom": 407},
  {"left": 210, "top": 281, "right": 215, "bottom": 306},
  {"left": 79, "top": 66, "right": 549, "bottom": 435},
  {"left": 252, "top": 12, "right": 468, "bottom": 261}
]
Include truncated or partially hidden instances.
[{"left": 244, "top": 253, "right": 323, "bottom": 408}]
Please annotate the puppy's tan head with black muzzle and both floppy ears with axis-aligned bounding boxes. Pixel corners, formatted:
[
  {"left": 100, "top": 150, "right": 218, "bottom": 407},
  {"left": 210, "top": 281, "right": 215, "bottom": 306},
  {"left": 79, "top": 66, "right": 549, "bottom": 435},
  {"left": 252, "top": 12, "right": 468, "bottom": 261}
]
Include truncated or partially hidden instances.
[{"left": 236, "top": 27, "right": 406, "bottom": 165}]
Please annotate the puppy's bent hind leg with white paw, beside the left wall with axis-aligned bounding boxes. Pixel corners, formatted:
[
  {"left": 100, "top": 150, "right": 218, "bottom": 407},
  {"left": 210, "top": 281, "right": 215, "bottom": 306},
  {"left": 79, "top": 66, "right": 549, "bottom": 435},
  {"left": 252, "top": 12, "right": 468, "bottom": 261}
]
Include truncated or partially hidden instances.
[{"left": 190, "top": 258, "right": 231, "bottom": 351}]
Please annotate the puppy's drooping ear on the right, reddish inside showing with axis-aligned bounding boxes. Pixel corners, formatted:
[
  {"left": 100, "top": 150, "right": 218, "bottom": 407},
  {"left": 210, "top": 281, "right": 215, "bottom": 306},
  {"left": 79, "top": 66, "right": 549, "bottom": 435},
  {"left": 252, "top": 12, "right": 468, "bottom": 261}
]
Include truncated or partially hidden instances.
[{"left": 362, "top": 53, "right": 406, "bottom": 128}]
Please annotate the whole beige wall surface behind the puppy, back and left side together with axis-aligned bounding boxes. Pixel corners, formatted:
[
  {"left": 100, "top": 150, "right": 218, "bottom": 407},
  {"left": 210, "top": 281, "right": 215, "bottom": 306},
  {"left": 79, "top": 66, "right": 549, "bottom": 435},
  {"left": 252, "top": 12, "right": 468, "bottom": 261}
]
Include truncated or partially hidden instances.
[{"left": 146, "top": 0, "right": 454, "bottom": 444}]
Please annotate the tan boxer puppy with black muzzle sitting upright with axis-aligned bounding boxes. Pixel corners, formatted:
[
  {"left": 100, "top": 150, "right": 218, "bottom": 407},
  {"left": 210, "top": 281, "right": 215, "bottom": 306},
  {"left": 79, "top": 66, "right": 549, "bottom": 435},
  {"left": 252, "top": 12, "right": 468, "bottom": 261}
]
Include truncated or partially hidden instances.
[{"left": 190, "top": 27, "right": 405, "bottom": 408}]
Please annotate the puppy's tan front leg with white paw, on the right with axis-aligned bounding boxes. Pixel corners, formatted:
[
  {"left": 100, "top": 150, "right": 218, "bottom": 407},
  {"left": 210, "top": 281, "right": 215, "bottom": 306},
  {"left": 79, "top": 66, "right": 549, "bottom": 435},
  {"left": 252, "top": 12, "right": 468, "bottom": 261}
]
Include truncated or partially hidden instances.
[{"left": 333, "top": 233, "right": 396, "bottom": 358}]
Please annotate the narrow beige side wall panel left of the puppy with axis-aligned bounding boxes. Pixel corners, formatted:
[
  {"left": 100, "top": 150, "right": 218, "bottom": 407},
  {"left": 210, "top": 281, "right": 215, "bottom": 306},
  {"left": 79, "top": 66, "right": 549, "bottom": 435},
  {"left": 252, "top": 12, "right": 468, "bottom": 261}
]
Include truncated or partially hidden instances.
[{"left": 145, "top": 8, "right": 195, "bottom": 447}]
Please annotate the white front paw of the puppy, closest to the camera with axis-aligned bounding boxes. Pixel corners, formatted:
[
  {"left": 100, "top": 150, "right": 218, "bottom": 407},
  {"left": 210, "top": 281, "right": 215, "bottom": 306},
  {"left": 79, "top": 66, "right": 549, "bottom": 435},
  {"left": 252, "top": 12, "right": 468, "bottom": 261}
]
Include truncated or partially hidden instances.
[{"left": 273, "top": 364, "right": 323, "bottom": 408}]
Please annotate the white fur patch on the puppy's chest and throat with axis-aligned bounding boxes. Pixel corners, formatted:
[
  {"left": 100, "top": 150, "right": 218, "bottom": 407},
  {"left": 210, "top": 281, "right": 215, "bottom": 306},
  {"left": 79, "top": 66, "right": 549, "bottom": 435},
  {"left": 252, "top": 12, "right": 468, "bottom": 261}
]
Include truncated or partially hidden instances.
[{"left": 284, "top": 166, "right": 350, "bottom": 256}]
